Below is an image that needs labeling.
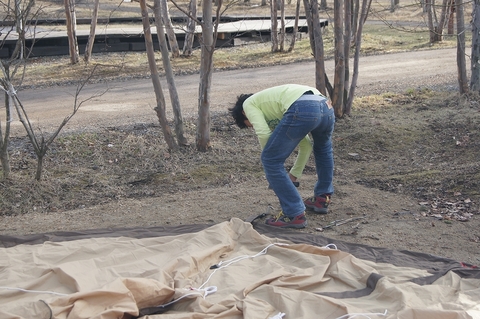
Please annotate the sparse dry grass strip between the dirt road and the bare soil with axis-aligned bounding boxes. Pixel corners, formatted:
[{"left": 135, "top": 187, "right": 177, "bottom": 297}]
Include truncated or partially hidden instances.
[{"left": 0, "top": 90, "right": 480, "bottom": 219}]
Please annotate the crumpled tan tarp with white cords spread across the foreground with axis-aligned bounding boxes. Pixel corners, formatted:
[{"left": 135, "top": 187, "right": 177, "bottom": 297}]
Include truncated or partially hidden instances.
[{"left": 0, "top": 219, "right": 480, "bottom": 319}]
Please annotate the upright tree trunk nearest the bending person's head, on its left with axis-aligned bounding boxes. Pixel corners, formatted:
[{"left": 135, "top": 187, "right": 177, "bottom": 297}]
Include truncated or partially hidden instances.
[{"left": 196, "top": 1, "right": 216, "bottom": 152}]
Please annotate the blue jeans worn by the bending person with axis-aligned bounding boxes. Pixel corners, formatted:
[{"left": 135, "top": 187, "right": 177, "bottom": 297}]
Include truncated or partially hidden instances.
[{"left": 261, "top": 95, "right": 335, "bottom": 218}]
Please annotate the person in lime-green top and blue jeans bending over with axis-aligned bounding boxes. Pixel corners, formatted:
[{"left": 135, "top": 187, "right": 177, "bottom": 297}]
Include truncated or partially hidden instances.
[{"left": 229, "top": 84, "right": 335, "bottom": 228}]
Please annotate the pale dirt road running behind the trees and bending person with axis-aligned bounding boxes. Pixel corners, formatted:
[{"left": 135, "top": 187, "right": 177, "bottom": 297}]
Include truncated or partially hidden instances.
[{"left": 14, "top": 49, "right": 457, "bottom": 134}]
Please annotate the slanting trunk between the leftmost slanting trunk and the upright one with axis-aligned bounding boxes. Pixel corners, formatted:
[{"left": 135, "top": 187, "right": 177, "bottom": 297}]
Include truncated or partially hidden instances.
[{"left": 154, "top": 0, "right": 188, "bottom": 146}]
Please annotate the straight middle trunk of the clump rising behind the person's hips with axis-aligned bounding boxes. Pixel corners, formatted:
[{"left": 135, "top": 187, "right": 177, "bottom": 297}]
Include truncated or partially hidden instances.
[{"left": 332, "top": 0, "right": 345, "bottom": 118}]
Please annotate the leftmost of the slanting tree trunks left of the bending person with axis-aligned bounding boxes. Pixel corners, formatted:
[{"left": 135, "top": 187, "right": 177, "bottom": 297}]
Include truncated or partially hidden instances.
[{"left": 140, "top": 0, "right": 177, "bottom": 150}]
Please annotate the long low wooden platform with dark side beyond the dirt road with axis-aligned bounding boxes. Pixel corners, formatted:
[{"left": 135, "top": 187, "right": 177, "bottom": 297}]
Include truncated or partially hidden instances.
[{"left": 0, "top": 17, "right": 328, "bottom": 58}]
